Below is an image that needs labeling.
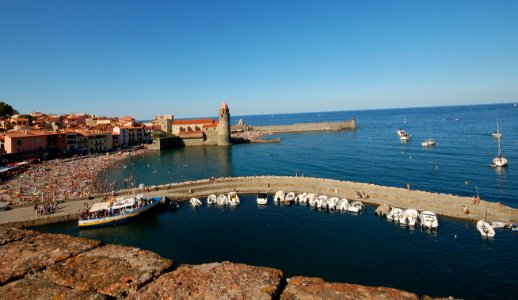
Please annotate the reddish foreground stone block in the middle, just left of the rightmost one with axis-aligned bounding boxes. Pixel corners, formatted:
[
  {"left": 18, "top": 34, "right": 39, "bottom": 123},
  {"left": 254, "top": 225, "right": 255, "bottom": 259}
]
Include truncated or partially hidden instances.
[{"left": 131, "top": 262, "right": 284, "bottom": 299}]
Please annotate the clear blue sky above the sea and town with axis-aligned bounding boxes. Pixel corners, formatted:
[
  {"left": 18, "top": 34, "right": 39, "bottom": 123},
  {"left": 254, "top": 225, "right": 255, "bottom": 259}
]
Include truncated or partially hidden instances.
[{"left": 0, "top": 0, "right": 518, "bottom": 119}]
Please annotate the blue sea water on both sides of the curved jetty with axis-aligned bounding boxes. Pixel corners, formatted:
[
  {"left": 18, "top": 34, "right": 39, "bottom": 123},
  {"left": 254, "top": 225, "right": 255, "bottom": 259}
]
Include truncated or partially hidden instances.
[{"left": 35, "top": 103, "right": 518, "bottom": 299}]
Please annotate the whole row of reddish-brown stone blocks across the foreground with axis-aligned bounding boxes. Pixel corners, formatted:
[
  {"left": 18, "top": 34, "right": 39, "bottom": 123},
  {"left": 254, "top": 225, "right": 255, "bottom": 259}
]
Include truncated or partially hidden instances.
[{"left": 0, "top": 229, "right": 436, "bottom": 299}]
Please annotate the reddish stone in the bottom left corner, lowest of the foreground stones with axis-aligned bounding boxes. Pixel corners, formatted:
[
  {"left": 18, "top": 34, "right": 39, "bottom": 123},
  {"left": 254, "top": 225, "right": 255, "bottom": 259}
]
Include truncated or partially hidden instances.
[{"left": 0, "top": 279, "right": 108, "bottom": 300}]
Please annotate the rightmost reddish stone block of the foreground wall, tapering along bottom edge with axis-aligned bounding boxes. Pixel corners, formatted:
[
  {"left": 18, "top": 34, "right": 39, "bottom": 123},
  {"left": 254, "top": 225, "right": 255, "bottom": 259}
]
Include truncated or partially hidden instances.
[{"left": 281, "top": 276, "right": 419, "bottom": 300}]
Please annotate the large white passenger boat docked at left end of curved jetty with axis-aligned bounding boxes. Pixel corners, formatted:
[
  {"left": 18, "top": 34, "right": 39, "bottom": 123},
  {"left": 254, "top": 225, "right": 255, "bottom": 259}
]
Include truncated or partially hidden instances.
[{"left": 78, "top": 195, "right": 161, "bottom": 228}]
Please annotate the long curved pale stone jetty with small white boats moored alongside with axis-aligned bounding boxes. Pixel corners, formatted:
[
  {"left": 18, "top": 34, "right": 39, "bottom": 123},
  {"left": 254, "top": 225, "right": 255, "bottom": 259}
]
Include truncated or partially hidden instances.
[{"left": 0, "top": 176, "right": 518, "bottom": 227}]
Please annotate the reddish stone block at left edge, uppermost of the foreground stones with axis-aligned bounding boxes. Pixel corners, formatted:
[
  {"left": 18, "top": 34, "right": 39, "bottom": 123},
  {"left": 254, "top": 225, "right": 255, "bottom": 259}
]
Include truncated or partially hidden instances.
[{"left": 0, "top": 233, "right": 100, "bottom": 284}]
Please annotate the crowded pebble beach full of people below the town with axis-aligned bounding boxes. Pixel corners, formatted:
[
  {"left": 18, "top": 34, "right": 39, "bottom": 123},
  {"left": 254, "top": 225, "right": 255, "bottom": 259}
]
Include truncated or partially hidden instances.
[{"left": 0, "top": 149, "right": 147, "bottom": 205}]
